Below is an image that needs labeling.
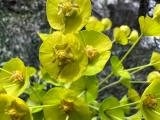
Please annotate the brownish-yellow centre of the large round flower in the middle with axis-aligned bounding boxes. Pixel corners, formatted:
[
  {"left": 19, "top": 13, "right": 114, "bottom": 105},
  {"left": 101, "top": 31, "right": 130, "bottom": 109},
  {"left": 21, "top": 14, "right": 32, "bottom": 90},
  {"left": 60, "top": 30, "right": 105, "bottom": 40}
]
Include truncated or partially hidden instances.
[{"left": 54, "top": 44, "right": 73, "bottom": 66}]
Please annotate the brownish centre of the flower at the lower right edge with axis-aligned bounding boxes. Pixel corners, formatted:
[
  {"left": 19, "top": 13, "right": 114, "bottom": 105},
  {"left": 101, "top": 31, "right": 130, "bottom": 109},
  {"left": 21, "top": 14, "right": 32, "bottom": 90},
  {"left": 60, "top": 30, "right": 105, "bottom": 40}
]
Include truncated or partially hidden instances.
[{"left": 143, "top": 94, "right": 158, "bottom": 109}]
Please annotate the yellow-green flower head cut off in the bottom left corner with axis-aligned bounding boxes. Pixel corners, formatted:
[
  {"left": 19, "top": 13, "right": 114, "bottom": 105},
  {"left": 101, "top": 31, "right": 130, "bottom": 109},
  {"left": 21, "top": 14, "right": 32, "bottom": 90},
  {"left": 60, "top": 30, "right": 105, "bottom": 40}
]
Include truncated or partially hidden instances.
[{"left": 0, "top": 94, "right": 32, "bottom": 120}]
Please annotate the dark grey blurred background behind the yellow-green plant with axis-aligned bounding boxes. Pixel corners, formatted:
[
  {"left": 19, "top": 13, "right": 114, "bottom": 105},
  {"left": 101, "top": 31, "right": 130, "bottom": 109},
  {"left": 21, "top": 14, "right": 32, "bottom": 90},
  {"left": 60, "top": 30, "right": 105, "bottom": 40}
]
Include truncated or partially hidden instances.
[{"left": 0, "top": 0, "right": 160, "bottom": 96}]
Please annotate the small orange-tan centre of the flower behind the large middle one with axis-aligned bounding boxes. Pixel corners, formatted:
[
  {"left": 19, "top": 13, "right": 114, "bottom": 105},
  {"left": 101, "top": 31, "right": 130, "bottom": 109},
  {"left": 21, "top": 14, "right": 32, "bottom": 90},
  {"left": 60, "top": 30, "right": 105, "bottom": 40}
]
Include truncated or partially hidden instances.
[{"left": 85, "top": 45, "right": 98, "bottom": 60}]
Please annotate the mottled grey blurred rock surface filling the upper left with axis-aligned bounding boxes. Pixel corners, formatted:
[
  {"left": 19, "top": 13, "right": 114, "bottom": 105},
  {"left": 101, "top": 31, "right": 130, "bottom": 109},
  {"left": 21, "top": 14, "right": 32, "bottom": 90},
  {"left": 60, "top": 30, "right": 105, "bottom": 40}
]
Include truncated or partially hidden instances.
[{"left": 0, "top": 0, "right": 49, "bottom": 67}]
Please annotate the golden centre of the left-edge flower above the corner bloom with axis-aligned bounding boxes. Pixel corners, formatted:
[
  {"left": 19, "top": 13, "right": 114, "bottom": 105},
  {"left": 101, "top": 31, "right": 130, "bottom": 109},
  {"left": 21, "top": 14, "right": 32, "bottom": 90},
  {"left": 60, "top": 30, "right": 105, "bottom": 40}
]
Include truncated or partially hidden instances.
[{"left": 11, "top": 71, "right": 24, "bottom": 82}]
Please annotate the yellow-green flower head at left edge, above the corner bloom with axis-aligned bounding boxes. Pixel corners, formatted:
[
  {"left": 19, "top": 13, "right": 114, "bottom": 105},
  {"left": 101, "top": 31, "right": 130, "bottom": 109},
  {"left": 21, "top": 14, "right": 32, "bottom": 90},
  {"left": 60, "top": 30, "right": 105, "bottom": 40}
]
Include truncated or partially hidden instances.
[{"left": 0, "top": 58, "right": 35, "bottom": 96}]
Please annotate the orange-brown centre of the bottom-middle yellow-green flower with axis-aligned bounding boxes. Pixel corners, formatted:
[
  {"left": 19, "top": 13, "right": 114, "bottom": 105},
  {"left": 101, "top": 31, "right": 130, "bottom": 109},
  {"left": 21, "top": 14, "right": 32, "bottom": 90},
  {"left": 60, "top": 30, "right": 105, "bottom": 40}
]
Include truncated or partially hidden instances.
[{"left": 61, "top": 100, "right": 73, "bottom": 113}]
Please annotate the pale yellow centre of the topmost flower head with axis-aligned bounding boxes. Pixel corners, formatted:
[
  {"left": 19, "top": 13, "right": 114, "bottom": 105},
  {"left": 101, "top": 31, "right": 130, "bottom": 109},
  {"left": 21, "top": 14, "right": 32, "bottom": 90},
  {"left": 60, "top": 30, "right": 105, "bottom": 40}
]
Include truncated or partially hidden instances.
[{"left": 58, "top": 0, "right": 79, "bottom": 16}]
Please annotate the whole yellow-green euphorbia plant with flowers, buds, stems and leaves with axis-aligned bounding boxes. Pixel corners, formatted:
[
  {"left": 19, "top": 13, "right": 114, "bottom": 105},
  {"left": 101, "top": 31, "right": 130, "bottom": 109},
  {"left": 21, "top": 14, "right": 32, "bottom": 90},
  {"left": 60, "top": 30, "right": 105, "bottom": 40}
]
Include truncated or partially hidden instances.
[{"left": 0, "top": 0, "right": 160, "bottom": 120}]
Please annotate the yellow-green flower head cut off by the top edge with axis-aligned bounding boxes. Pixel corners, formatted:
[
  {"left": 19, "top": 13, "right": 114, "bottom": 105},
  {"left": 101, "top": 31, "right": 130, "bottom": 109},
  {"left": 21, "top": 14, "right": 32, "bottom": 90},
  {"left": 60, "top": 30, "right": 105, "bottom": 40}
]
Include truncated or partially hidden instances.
[{"left": 46, "top": 0, "right": 91, "bottom": 33}]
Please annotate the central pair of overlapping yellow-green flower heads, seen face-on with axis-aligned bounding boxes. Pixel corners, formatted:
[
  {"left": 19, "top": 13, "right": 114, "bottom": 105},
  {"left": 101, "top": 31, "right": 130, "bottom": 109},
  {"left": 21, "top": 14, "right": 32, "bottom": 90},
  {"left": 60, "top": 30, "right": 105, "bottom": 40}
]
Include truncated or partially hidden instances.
[{"left": 39, "top": 31, "right": 112, "bottom": 82}]
